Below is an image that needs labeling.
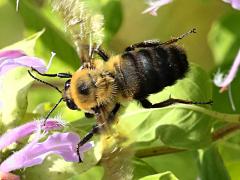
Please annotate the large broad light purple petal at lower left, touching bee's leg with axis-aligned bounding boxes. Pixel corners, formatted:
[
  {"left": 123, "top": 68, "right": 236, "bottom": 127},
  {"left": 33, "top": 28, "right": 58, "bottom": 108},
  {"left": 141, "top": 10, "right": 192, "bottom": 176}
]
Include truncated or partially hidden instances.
[{"left": 0, "top": 133, "right": 92, "bottom": 172}]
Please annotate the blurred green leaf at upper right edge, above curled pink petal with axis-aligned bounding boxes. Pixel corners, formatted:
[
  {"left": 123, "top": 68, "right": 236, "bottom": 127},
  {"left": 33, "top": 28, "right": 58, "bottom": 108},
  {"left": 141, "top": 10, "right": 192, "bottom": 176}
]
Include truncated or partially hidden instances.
[{"left": 208, "top": 11, "right": 240, "bottom": 65}]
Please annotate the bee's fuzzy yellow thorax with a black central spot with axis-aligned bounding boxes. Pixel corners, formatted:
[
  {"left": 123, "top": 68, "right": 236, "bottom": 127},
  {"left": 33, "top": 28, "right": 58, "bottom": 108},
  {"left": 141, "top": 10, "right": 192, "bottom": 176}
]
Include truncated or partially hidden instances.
[{"left": 68, "top": 68, "right": 115, "bottom": 113}]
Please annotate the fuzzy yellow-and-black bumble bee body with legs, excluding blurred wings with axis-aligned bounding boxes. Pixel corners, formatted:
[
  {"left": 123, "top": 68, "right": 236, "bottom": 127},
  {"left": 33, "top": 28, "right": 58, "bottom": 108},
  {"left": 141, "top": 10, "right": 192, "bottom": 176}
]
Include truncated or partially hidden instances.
[{"left": 29, "top": 29, "right": 211, "bottom": 161}]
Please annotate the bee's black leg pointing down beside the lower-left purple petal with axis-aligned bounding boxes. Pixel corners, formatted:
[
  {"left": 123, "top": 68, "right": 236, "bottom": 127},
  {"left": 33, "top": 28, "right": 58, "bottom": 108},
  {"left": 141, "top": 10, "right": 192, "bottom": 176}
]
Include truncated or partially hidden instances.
[{"left": 77, "top": 124, "right": 101, "bottom": 162}]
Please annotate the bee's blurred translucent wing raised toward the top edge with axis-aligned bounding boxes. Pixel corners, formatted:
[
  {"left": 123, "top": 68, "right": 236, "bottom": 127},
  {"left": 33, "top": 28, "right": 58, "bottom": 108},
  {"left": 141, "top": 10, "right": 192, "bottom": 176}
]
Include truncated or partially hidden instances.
[{"left": 52, "top": 0, "right": 104, "bottom": 63}]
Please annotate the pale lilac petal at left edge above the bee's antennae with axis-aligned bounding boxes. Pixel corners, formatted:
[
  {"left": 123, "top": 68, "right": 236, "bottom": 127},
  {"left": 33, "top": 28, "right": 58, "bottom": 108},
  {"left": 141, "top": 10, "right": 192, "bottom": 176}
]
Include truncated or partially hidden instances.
[{"left": 0, "top": 50, "right": 55, "bottom": 76}]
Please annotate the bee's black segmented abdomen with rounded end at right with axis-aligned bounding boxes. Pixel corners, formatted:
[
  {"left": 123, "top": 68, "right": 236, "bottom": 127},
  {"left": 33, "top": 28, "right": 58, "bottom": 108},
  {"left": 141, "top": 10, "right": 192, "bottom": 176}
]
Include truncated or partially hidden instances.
[{"left": 121, "top": 45, "right": 189, "bottom": 99}]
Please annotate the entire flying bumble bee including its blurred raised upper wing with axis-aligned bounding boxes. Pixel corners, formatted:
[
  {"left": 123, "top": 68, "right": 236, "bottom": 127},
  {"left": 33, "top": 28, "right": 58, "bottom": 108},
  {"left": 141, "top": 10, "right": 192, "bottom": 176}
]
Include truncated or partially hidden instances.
[{"left": 28, "top": 0, "right": 211, "bottom": 162}]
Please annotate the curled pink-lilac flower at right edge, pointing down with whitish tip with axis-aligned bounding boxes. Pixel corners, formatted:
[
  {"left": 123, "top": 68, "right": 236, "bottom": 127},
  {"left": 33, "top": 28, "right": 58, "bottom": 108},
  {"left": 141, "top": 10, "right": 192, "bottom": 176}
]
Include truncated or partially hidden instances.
[{"left": 213, "top": 50, "right": 240, "bottom": 92}]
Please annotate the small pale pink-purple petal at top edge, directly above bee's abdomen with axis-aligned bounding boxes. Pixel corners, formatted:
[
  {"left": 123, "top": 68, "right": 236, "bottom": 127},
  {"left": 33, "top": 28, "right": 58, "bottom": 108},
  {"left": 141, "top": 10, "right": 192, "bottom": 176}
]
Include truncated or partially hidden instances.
[{"left": 142, "top": 0, "right": 172, "bottom": 16}]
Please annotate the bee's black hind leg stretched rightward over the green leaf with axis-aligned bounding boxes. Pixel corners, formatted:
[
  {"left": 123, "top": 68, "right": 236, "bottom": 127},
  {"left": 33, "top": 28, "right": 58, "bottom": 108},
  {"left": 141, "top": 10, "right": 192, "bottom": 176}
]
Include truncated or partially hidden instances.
[{"left": 140, "top": 98, "right": 213, "bottom": 108}]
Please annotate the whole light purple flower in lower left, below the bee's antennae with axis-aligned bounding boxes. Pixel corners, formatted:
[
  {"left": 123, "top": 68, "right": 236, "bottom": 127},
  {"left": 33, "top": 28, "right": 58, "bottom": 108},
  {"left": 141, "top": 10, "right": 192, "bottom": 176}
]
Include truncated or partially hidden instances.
[{"left": 0, "top": 121, "right": 93, "bottom": 172}]
